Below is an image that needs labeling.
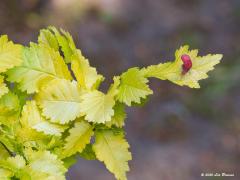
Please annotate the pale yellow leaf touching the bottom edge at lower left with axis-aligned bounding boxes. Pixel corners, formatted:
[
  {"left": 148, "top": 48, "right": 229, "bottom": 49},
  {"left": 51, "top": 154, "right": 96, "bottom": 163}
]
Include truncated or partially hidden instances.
[{"left": 27, "top": 151, "right": 67, "bottom": 179}]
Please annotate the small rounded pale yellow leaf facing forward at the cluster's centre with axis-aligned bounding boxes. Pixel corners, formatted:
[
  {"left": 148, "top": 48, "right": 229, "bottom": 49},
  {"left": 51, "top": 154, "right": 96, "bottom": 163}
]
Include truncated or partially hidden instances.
[{"left": 80, "top": 90, "right": 115, "bottom": 123}]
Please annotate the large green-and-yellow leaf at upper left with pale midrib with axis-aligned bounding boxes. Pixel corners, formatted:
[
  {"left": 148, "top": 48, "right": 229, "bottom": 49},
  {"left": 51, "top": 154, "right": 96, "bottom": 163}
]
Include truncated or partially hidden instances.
[{"left": 7, "top": 44, "right": 71, "bottom": 94}]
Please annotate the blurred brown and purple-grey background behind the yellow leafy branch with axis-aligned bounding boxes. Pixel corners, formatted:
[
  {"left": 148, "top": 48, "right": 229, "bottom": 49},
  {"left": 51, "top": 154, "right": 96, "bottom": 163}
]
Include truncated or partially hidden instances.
[{"left": 0, "top": 0, "right": 240, "bottom": 180}]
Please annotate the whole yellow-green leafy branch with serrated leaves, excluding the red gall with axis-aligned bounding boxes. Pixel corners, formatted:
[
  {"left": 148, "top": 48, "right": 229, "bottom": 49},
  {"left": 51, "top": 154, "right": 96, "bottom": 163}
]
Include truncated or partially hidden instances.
[{"left": 0, "top": 27, "right": 222, "bottom": 180}]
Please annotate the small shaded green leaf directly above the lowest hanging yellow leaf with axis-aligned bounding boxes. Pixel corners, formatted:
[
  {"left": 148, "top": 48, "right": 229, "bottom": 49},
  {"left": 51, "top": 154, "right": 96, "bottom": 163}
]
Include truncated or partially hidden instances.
[{"left": 106, "top": 103, "right": 127, "bottom": 128}]
